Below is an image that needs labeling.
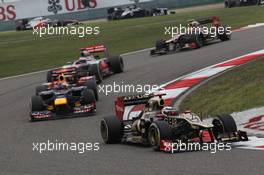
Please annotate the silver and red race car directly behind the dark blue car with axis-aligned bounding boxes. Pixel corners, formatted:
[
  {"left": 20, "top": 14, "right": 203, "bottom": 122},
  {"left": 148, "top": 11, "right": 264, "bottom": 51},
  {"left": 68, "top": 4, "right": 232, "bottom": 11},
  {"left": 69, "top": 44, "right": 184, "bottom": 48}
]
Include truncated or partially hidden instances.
[{"left": 47, "top": 45, "right": 124, "bottom": 82}]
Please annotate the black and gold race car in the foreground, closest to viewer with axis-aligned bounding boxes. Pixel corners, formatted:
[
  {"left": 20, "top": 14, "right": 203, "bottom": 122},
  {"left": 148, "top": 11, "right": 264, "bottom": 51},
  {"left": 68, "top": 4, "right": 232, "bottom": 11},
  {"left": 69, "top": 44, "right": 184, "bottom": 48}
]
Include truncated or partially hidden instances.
[{"left": 100, "top": 94, "right": 248, "bottom": 151}]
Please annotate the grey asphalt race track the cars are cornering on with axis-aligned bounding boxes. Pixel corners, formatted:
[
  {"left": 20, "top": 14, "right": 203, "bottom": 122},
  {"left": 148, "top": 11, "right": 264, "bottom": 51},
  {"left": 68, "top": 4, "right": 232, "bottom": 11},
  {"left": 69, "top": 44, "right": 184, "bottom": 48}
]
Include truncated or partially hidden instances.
[{"left": 0, "top": 27, "right": 264, "bottom": 175}]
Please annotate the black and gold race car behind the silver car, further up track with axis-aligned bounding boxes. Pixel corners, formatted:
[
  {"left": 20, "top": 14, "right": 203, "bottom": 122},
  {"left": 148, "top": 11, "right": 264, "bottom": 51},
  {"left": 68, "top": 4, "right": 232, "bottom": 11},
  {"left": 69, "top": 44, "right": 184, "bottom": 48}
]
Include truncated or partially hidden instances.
[{"left": 150, "top": 16, "right": 231, "bottom": 55}]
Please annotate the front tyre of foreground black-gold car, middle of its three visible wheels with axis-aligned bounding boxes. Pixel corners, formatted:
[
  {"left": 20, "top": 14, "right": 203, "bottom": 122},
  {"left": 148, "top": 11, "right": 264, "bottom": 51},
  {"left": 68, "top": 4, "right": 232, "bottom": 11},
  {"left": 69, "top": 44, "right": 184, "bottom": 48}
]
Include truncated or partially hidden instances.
[{"left": 148, "top": 121, "right": 172, "bottom": 151}]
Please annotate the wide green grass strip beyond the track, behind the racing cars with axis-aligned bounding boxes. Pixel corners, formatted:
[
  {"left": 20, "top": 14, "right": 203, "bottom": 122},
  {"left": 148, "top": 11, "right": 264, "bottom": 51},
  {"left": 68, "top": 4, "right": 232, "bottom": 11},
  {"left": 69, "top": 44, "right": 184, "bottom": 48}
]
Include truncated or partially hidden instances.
[{"left": 0, "top": 7, "right": 264, "bottom": 77}]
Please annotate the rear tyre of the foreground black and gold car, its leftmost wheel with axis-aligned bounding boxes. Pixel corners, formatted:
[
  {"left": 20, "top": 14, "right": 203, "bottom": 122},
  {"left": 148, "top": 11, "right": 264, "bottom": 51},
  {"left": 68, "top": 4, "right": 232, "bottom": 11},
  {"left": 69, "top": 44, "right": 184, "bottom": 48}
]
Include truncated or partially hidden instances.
[{"left": 100, "top": 116, "right": 124, "bottom": 144}]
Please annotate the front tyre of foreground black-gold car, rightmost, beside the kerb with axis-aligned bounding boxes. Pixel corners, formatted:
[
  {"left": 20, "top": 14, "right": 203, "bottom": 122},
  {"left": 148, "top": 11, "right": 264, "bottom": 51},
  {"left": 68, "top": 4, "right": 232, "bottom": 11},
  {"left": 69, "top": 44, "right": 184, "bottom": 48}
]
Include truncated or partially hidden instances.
[{"left": 212, "top": 114, "right": 237, "bottom": 137}]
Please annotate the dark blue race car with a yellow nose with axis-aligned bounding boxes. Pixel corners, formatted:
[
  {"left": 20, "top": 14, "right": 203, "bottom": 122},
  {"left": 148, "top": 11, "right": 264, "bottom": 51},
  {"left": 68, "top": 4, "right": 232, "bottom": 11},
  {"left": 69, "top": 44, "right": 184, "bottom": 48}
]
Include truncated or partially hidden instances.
[{"left": 30, "top": 74, "right": 98, "bottom": 121}]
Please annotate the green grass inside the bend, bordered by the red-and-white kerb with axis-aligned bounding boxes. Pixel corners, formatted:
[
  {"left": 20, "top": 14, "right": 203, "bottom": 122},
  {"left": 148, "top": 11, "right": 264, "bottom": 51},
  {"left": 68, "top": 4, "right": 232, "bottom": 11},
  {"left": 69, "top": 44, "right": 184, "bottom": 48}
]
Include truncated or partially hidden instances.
[{"left": 180, "top": 58, "right": 264, "bottom": 116}]
